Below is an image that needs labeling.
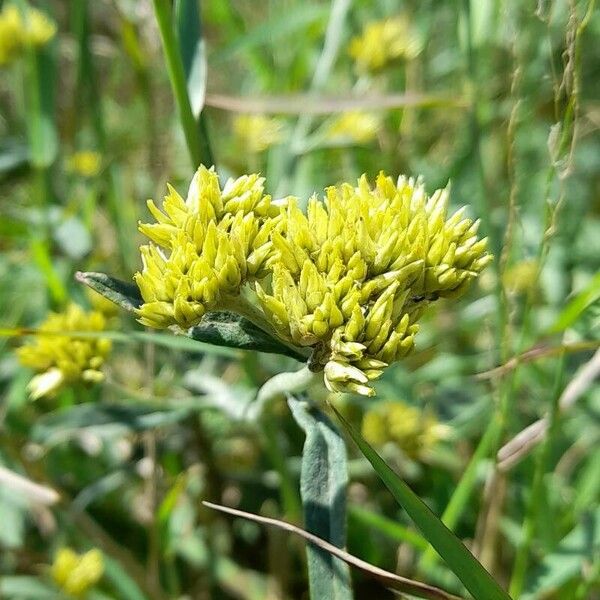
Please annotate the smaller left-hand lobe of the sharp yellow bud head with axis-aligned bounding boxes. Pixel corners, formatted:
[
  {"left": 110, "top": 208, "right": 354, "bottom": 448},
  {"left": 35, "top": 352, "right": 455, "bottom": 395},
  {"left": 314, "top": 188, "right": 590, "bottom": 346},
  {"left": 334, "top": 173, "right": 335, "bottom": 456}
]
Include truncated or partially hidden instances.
[{"left": 135, "top": 166, "right": 279, "bottom": 330}]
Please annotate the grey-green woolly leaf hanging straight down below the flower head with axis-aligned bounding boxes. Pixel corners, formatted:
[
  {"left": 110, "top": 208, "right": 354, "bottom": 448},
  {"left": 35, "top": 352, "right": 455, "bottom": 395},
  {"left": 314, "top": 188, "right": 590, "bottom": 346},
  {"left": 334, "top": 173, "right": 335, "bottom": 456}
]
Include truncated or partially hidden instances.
[{"left": 288, "top": 395, "right": 352, "bottom": 600}]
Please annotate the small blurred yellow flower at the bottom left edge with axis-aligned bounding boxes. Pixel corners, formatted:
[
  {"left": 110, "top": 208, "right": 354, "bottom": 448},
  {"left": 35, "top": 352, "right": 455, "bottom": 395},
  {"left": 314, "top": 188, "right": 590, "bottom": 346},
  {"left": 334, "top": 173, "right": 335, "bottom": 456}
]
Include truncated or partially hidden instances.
[{"left": 50, "top": 548, "right": 104, "bottom": 597}]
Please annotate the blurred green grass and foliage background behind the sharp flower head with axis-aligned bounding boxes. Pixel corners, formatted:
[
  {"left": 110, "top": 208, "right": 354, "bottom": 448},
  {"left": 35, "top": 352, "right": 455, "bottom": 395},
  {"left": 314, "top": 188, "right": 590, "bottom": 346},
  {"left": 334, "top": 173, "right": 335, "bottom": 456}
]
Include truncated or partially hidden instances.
[{"left": 0, "top": 0, "right": 600, "bottom": 600}]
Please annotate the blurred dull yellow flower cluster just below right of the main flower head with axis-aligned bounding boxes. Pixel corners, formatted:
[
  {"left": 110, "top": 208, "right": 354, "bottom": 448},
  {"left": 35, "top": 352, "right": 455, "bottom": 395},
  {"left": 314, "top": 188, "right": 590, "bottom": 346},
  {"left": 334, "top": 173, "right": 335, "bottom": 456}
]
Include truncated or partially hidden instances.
[{"left": 362, "top": 401, "right": 448, "bottom": 458}]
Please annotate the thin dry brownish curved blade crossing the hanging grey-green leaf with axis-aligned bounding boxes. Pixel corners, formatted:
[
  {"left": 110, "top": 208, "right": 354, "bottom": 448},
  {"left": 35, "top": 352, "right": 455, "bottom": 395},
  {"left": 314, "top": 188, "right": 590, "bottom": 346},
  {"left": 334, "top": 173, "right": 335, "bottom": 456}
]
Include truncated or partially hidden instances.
[{"left": 202, "top": 501, "right": 461, "bottom": 600}]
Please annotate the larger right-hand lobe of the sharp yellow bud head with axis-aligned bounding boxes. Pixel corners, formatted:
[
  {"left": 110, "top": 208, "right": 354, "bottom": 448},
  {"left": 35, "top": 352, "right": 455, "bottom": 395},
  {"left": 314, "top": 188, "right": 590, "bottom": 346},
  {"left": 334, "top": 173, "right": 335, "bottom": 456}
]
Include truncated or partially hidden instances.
[{"left": 256, "top": 173, "right": 492, "bottom": 396}]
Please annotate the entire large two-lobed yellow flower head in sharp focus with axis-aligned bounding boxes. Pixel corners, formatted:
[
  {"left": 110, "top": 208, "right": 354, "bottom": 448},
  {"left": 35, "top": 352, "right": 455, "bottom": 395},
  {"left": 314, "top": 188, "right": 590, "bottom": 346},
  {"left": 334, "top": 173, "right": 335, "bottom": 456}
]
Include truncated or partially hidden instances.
[{"left": 135, "top": 167, "right": 492, "bottom": 396}]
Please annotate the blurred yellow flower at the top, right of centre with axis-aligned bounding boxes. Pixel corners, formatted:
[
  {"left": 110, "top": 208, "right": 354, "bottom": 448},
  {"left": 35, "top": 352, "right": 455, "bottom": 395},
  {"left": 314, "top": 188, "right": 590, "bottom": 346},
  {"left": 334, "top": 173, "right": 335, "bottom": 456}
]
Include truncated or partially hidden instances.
[{"left": 348, "top": 17, "right": 421, "bottom": 73}]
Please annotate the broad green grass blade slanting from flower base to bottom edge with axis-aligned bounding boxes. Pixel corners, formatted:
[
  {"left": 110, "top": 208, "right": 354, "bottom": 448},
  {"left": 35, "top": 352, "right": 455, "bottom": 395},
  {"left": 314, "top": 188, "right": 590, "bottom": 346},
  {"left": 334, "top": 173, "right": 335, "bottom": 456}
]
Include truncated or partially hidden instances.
[{"left": 333, "top": 400, "right": 510, "bottom": 600}]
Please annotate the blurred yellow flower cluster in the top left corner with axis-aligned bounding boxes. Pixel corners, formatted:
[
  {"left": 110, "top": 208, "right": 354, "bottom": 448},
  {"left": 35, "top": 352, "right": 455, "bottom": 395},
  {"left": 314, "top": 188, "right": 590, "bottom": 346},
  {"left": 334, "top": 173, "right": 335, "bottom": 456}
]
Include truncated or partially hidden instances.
[{"left": 0, "top": 4, "right": 56, "bottom": 66}]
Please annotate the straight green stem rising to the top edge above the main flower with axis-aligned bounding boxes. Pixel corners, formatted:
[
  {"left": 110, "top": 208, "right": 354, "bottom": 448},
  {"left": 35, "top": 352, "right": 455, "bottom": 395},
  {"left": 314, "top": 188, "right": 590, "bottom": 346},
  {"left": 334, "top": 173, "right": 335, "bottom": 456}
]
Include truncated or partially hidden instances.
[{"left": 153, "top": 0, "right": 202, "bottom": 168}]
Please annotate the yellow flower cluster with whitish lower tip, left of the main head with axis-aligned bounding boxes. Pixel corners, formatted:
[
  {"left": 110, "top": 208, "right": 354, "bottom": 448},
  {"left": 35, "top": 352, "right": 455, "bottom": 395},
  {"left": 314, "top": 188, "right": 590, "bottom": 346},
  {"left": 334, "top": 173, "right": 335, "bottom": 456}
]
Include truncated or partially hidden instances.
[{"left": 17, "top": 304, "right": 111, "bottom": 400}]
